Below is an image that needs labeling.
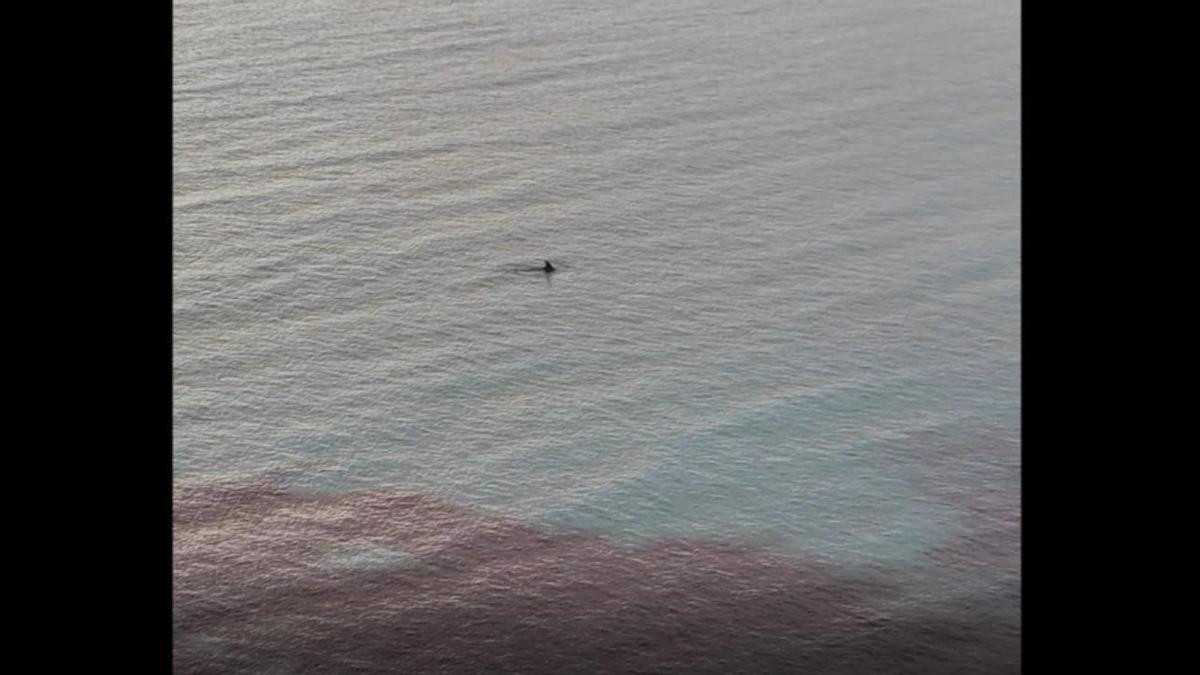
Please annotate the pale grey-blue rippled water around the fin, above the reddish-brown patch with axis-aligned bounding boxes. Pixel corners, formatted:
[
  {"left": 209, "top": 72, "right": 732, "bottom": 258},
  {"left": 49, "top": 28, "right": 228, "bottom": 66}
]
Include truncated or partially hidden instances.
[{"left": 173, "top": 0, "right": 1020, "bottom": 667}]
